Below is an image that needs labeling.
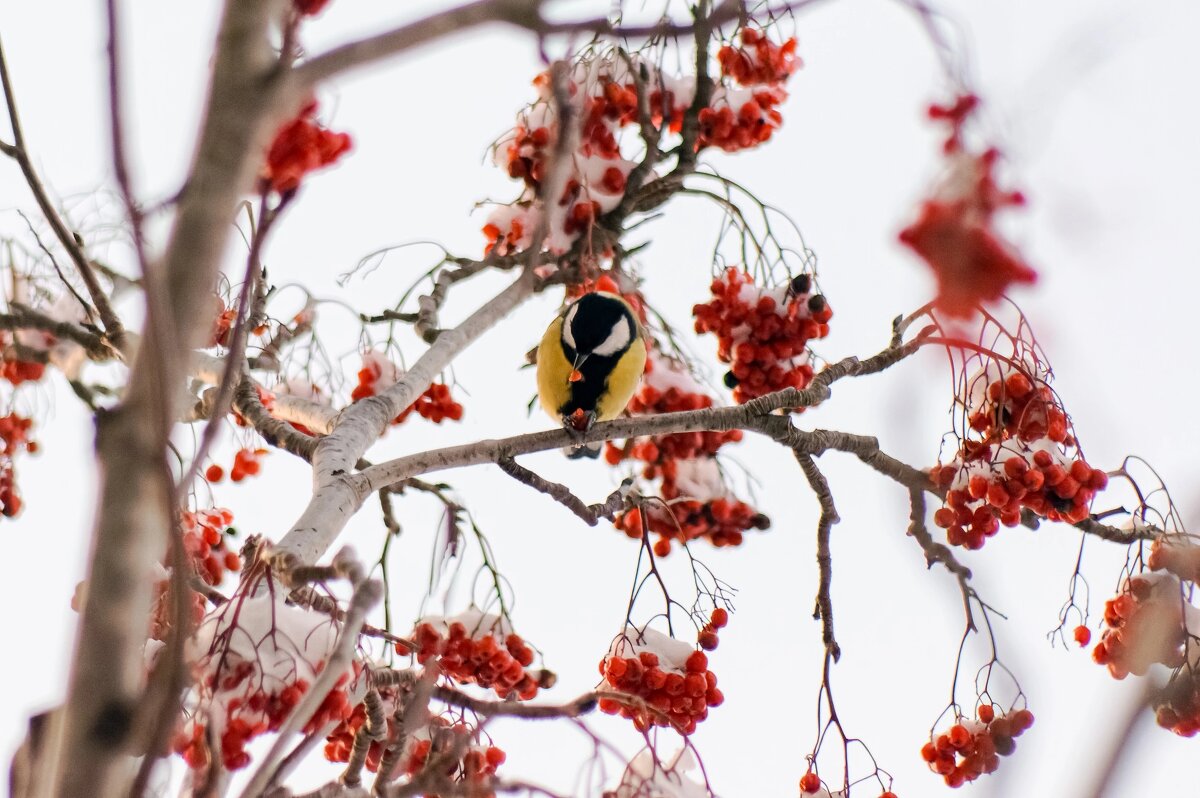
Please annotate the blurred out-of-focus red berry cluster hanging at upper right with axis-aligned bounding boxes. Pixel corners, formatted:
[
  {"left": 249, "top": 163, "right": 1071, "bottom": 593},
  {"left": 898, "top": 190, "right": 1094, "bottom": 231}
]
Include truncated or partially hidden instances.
[{"left": 900, "top": 95, "right": 1037, "bottom": 318}]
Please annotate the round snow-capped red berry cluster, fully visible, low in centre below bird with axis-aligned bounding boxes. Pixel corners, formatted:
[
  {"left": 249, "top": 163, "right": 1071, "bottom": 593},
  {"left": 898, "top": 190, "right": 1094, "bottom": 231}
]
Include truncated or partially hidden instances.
[{"left": 599, "top": 629, "right": 725, "bottom": 734}]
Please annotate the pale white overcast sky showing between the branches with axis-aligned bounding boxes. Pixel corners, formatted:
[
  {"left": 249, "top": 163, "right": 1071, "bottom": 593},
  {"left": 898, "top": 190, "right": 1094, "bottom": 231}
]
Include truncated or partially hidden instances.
[{"left": 0, "top": 0, "right": 1200, "bottom": 798}]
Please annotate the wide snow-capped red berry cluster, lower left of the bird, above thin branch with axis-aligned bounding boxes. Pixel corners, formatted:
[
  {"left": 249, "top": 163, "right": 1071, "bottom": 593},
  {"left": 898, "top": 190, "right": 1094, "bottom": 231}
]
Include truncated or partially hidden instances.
[{"left": 412, "top": 611, "right": 542, "bottom": 701}]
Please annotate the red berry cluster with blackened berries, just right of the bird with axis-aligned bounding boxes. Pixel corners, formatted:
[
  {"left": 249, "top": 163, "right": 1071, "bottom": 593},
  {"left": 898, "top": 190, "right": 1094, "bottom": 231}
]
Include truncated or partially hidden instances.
[{"left": 691, "top": 268, "right": 833, "bottom": 404}]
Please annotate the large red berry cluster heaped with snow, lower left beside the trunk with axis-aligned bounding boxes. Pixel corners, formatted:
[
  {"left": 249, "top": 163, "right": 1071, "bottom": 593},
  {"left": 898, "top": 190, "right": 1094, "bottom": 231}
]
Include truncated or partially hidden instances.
[{"left": 174, "top": 590, "right": 352, "bottom": 770}]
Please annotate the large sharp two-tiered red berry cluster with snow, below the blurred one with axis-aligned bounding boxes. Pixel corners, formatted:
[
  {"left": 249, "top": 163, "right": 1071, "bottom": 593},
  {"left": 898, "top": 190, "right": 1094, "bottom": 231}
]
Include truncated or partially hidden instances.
[{"left": 930, "top": 362, "right": 1108, "bottom": 548}]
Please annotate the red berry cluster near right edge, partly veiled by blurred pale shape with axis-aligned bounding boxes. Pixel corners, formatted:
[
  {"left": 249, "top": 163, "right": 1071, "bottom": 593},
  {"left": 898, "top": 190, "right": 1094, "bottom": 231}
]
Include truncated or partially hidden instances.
[{"left": 1092, "top": 574, "right": 1190, "bottom": 679}]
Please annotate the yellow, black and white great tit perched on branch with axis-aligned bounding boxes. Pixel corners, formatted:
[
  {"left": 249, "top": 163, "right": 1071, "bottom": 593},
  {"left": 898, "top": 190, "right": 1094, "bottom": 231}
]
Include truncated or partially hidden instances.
[{"left": 538, "top": 292, "right": 646, "bottom": 457}]
